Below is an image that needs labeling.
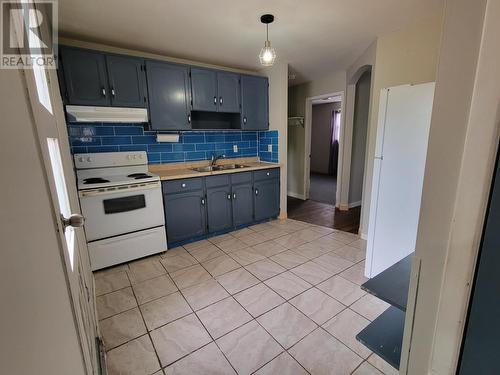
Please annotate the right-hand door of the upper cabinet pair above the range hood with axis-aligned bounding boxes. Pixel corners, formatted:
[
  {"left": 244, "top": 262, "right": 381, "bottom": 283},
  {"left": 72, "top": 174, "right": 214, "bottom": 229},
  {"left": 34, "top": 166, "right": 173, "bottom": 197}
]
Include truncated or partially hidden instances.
[{"left": 106, "top": 55, "right": 146, "bottom": 107}]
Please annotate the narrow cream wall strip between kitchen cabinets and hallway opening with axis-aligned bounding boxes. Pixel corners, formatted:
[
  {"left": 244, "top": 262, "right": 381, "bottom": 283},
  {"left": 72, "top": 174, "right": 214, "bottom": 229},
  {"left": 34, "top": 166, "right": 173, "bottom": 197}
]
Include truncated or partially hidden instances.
[{"left": 261, "top": 60, "right": 288, "bottom": 219}]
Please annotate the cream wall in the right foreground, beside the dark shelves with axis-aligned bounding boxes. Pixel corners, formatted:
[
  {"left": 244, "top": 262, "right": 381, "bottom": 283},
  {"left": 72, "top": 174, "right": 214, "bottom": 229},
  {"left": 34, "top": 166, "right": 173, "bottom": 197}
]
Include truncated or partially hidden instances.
[{"left": 404, "top": 0, "right": 500, "bottom": 374}]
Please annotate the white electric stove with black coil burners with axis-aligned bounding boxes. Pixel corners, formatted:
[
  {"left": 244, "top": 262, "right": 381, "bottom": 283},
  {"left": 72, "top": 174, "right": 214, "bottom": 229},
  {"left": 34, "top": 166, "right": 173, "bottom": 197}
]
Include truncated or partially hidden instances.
[{"left": 74, "top": 151, "right": 167, "bottom": 270}]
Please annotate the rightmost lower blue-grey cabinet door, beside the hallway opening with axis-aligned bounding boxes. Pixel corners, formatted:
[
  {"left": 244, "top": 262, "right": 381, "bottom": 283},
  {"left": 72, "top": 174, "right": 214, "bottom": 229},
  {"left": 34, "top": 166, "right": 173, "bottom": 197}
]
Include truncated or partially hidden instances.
[{"left": 254, "top": 179, "right": 280, "bottom": 221}]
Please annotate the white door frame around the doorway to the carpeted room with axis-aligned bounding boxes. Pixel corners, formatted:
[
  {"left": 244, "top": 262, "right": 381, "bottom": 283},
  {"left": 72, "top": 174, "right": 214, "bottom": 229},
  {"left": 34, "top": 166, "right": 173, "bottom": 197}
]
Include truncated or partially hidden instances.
[{"left": 303, "top": 91, "right": 344, "bottom": 207}]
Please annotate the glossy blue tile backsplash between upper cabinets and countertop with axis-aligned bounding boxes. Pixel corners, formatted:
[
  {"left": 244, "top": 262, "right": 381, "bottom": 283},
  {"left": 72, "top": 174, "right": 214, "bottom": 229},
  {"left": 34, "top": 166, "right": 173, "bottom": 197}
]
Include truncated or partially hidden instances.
[{"left": 68, "top": 123, "right": 278, "bottom": 164}]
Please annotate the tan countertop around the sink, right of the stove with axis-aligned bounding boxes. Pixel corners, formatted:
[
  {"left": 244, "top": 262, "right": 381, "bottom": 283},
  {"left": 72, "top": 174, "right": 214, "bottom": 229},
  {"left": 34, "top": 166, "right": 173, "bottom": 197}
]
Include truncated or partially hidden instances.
[{"left": 149, "top": 158, "right": 281, "bottom": 180}]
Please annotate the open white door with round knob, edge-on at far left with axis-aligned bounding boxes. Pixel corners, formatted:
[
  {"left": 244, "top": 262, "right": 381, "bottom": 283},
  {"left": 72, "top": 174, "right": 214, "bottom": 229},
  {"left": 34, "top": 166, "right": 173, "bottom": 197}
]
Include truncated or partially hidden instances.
[{"left": 18, "top": 4, "right": 98, "bottom": 374}]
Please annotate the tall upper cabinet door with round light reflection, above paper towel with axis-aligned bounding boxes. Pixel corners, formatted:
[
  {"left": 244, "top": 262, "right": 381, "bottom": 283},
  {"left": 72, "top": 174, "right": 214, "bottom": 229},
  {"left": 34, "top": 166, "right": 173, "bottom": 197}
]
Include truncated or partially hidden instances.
[{"left": 146, "top": 61, "right": 191, "bottom": 130}]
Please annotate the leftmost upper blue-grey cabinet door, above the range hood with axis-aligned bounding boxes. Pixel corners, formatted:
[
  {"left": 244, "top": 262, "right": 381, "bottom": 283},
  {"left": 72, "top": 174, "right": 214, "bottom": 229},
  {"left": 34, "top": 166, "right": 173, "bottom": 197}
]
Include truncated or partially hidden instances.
[{"left": 60, "top": 47, "right": 111, "bottom": 106}]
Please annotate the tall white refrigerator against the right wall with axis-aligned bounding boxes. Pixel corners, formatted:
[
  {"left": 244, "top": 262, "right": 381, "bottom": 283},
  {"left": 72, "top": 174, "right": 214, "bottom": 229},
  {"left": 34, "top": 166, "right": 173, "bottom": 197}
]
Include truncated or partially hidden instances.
[{"left": 365, "top": 82, "right": 434, "bottom": 278}]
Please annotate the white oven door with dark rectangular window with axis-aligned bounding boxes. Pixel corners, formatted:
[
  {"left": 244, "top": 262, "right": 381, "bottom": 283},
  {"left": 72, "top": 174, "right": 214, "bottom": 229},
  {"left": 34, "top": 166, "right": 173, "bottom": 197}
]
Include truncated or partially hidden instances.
[{"left": 79, "top": 181, "right": 165, "bottom": 242}]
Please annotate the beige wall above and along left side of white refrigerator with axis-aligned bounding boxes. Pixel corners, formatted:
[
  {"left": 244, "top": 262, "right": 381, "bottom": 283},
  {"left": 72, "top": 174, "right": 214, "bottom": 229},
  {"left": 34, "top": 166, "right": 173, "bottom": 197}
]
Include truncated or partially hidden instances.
[{"left": 360, "top": 15, "right": 442, "bottom": 237}]
